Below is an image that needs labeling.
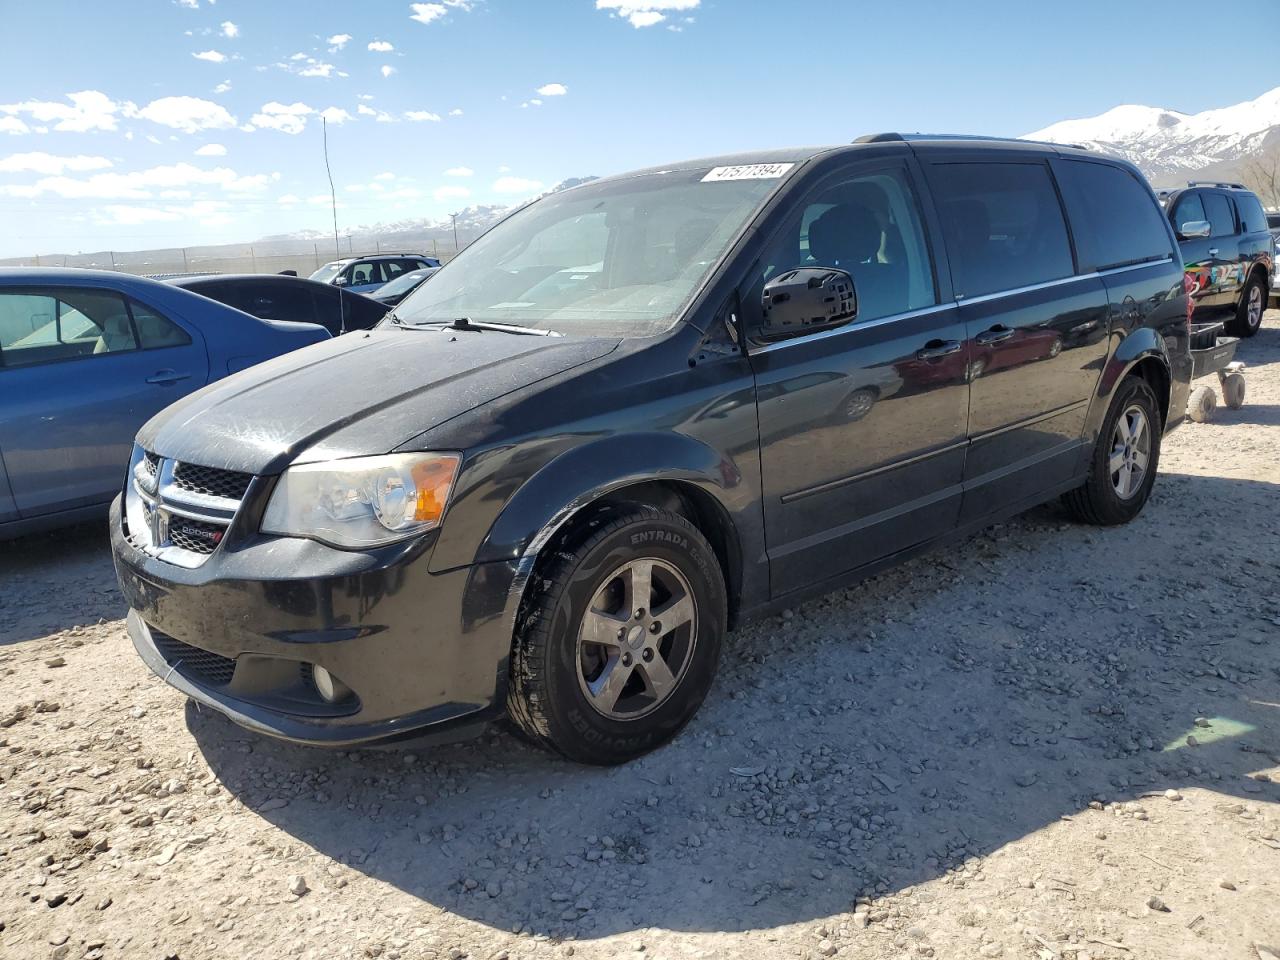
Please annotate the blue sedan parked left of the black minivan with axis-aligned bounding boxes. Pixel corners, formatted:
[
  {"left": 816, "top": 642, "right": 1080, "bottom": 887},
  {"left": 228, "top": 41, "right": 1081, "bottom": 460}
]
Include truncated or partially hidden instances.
[{"left": 0, "top": 268, "right": 329, "bottom": 539}]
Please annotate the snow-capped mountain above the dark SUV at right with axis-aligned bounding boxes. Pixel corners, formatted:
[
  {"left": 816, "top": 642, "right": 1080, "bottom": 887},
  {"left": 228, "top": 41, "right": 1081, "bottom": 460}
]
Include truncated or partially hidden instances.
[{"left": 1025, "top": 87, "right": 1280, "bottom": 186}]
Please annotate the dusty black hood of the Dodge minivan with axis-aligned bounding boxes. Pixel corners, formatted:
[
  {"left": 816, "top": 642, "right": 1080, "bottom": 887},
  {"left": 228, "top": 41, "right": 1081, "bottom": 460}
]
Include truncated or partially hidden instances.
[{"left": 138, "top": 328, "right": 620, "bottom": 475}]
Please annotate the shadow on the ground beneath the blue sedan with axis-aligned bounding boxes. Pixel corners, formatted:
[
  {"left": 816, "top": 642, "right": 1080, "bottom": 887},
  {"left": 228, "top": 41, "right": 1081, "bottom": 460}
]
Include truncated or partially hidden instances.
[{"left": 0, "top": 517, "right": 127, "bottom": 646}]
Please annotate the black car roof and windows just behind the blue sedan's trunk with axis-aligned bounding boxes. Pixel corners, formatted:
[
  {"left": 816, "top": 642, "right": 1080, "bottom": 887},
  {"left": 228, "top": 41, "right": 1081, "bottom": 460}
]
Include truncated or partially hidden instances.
[{"left": 169, "top": 274, "right": 387, "bottom": 337}]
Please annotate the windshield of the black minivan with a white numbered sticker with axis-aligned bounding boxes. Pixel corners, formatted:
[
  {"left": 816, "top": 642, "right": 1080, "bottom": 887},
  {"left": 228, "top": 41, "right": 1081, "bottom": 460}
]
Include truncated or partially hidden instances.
[{"left": 396, "top": 164, "right": 792, "bottom": 337}]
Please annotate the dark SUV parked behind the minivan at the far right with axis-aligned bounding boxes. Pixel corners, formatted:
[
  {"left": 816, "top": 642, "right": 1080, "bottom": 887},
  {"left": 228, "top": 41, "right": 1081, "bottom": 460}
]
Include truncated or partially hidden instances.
[{"left": 1162, "top": 180, "right": 1276, "bottom": 337}]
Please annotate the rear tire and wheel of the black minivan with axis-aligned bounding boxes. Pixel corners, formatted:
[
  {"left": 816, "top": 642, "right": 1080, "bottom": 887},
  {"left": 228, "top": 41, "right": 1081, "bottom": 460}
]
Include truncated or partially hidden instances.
[{"left": 1062, "top": 376, "right": 1164, "bottom": 526}]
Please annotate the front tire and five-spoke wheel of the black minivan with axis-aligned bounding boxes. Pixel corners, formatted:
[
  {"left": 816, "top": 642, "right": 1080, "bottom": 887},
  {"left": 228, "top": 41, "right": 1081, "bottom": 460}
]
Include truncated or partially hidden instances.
[{"left": 507, "top": 504, "right": 727, "bottom": 765}]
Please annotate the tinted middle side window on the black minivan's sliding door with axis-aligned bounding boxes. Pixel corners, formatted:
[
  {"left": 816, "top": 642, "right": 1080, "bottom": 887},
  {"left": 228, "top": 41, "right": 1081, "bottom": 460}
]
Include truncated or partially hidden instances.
[{"left": 929, "top": 163, "right": 1075, "bottom": 297}]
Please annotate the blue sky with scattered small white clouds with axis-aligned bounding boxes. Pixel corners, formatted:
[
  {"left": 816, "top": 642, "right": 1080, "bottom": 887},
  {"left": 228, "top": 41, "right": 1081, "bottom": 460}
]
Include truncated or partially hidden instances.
[{"left": 0, "top": 0, "right": 1280, "bottom": 256}]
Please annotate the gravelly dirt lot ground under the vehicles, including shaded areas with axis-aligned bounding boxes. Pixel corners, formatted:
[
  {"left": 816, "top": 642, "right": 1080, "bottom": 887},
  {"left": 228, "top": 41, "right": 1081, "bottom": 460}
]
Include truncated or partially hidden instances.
[{"left": 0, "top": 314, "right": 1280, "bottom": 960}]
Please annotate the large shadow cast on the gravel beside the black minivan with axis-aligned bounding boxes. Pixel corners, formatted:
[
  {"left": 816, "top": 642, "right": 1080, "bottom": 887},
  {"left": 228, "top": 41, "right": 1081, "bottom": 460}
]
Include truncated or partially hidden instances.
[{"left": 187, "top": 475, "right": 1280, "bottom": 938}]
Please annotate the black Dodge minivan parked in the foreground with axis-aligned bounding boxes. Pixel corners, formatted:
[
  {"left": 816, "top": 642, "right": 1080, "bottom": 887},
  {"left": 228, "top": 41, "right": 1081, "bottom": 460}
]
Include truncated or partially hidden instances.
[{"left": 111, "top": 134, "right": 1192, "bottom": 763}]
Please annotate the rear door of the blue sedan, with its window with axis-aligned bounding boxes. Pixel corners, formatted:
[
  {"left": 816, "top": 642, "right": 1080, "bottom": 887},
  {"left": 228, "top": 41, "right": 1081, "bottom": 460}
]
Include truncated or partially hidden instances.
[{"left": 0, "top": 287, "right": 209, "bottom": 517}]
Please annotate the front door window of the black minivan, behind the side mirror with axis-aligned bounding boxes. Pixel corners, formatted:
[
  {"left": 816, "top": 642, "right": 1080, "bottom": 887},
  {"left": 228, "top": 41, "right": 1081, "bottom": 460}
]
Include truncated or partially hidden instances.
[{"left": 742, "top": 169, "right": 938, "bottom": 329}]
